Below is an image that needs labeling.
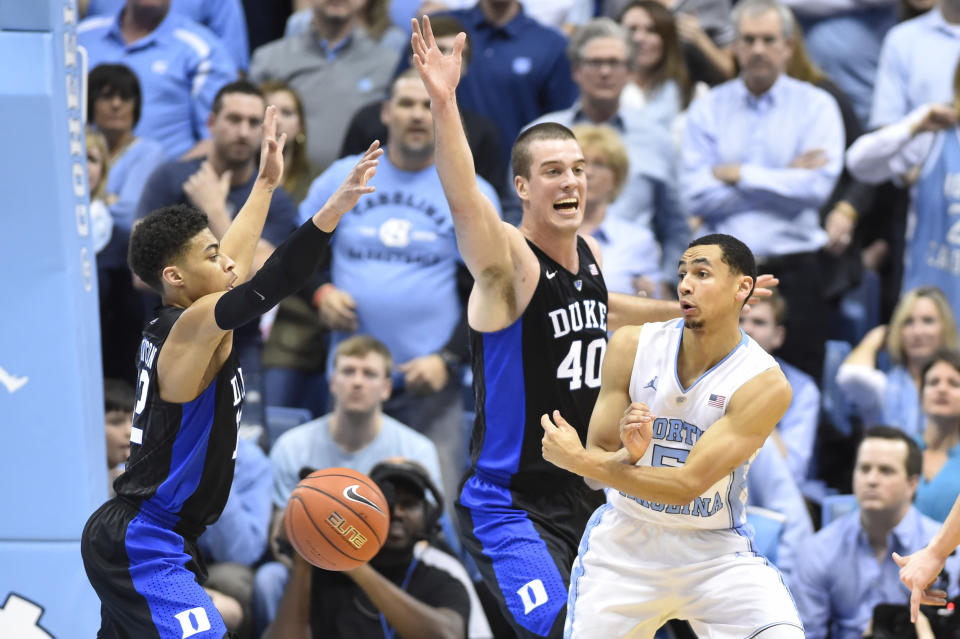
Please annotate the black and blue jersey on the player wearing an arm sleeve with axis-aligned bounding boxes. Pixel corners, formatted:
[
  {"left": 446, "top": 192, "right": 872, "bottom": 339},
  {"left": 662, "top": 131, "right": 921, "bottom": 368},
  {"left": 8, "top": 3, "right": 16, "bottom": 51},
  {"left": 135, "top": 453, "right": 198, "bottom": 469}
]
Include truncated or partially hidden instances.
[{"left": 114, "top": 306, "right": 244, "bottom": 537}]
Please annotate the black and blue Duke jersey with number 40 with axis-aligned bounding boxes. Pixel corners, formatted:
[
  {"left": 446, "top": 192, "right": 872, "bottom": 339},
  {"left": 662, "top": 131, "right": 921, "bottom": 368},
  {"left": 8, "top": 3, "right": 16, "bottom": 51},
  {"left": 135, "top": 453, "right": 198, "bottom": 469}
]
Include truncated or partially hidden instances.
[{"left": 470, "top": 237, "right": 607, "bottom": 491}]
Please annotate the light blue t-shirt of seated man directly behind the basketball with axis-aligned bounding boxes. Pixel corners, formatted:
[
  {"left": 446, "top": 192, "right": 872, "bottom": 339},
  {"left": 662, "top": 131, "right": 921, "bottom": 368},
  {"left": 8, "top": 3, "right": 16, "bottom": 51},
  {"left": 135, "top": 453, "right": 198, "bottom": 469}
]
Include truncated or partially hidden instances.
[{"left": 270, "top": 415, "right": 443, "bottom": 508}]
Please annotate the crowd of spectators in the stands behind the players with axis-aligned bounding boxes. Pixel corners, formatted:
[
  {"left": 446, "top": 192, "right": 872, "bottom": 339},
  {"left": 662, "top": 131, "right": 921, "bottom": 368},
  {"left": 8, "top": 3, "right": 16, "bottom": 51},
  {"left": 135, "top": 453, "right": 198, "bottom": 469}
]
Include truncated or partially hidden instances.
[{"left": 78, "top": 0, "right": 960, "bottom": 639}]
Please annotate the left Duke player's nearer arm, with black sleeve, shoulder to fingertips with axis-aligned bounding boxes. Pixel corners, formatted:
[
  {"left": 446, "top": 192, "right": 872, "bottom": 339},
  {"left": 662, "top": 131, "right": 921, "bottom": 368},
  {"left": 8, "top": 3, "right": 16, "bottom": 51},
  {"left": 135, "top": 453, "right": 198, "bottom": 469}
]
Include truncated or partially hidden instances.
[{"left": 157, "top": 148, "right": 383, "bottom": 402}]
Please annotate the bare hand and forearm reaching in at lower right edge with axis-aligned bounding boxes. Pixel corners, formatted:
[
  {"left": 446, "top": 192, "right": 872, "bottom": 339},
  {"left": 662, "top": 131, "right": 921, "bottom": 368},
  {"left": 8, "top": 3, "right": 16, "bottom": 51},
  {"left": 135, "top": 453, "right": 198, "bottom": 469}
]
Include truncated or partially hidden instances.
[{"left": 893, "top": 497, "right": 960, "bottom": 622}]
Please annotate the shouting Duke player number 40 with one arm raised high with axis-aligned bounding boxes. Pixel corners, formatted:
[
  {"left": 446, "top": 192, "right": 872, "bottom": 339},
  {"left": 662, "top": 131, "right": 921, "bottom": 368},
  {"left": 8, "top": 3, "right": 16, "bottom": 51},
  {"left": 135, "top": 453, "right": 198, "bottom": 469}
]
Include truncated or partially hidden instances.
[{"left": 411, "top": 18, "right": 776, "bottom": 638}]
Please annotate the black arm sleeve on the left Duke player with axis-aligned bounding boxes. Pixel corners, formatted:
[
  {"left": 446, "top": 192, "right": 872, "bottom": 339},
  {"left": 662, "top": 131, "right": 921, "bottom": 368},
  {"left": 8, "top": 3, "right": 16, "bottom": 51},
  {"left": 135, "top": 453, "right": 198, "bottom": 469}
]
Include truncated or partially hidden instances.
[{"left": 213, "top": 219, "right": 330, "bottom": 331}]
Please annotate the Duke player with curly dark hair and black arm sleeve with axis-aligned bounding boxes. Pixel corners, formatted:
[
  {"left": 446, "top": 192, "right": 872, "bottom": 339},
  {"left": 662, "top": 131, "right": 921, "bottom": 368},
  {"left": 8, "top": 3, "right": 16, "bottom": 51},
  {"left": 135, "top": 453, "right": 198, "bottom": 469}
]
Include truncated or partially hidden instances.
[{"left": 81, "top": 106, "right": 382, "bottom": 639}]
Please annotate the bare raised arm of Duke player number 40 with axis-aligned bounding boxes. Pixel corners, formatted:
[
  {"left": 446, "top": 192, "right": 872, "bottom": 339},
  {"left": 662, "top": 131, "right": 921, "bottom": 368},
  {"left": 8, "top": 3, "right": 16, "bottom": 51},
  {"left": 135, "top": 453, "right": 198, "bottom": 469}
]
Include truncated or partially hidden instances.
[{"left": 410, "top": 16, "right": 513, "bottom": 287}]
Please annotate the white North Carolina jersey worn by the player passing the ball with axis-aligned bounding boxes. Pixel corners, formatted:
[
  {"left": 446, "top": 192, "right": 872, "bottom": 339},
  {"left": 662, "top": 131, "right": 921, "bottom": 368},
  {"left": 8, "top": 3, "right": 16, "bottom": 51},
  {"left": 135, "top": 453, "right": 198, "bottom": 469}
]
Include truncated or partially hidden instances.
[{"left": 608, "top": 319, "right": 777, "bottom": 529}]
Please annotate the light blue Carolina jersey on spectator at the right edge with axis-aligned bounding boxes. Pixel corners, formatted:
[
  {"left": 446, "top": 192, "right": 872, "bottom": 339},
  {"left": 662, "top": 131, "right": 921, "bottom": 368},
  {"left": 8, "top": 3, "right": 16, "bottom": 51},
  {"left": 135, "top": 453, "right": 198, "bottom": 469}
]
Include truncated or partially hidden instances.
[{"left": 903, "top": 128, "right": 960, "bottom": 316}]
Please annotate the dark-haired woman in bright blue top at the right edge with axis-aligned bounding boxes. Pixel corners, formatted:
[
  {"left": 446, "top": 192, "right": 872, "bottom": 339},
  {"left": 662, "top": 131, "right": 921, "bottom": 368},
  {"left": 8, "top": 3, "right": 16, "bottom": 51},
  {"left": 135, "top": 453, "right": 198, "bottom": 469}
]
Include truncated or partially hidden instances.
[{"left": 914, "top": 350, "right": 960, "bottom": 521}]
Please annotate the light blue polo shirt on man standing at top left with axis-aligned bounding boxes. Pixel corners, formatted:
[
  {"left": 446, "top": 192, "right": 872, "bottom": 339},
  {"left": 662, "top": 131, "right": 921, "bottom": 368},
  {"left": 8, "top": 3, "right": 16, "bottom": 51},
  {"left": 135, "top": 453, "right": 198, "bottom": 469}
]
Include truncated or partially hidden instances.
[{"left": 77, "top": 0, "right": 236, "bottom": 158}]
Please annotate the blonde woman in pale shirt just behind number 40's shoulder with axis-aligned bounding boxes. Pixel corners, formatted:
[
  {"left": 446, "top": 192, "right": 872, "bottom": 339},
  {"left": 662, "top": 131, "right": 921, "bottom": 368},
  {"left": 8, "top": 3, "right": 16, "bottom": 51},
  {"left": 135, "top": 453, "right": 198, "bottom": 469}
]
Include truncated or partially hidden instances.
[{"left": 572, "top": 125, "right": 661, "bottom": 297}]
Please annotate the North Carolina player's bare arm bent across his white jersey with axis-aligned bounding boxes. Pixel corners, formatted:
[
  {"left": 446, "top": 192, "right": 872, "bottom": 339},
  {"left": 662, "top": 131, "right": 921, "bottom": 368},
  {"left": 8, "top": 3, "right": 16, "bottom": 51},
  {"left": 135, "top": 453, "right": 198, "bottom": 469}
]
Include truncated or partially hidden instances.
[{"left": 541, "top": 368, "right": 792, "bottom": 505}]
